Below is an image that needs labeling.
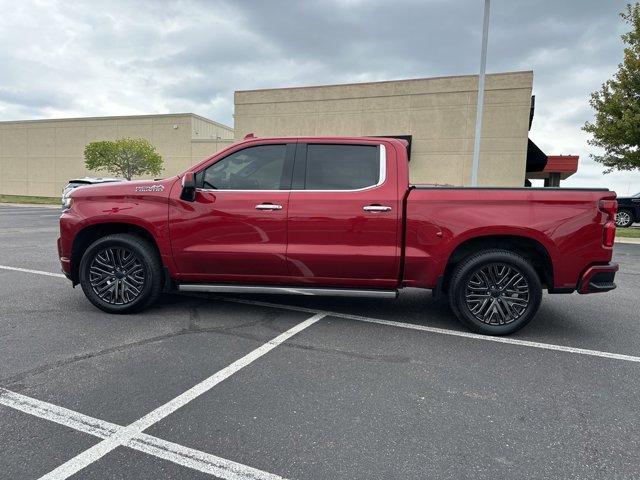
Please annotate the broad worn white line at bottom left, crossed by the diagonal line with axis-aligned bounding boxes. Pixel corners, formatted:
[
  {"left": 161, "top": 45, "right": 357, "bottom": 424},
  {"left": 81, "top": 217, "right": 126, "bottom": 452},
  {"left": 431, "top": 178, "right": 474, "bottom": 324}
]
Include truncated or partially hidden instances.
[{"left": 0, "top": 388, "right": 284, "bottom": 480}]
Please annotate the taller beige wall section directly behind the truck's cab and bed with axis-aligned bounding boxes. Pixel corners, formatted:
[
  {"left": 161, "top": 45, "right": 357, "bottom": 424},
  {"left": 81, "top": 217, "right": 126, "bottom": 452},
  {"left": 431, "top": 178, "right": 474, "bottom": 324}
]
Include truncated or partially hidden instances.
[{"left": 235, "top": 71, "right": 533, "bottom": 186}]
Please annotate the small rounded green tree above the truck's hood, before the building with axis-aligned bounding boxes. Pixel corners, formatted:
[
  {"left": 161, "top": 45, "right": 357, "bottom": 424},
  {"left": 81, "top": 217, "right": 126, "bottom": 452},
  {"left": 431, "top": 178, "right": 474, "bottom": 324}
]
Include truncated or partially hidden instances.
[{"left": 84, "top": 138, "right": 163, "bottom": 180}]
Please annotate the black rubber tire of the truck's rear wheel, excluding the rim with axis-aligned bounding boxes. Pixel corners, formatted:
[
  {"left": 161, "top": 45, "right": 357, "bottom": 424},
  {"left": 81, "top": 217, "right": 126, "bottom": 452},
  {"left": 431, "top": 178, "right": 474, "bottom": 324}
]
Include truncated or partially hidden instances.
[{"left": 451, "top": 252, "right": 542, "bottom": 335}]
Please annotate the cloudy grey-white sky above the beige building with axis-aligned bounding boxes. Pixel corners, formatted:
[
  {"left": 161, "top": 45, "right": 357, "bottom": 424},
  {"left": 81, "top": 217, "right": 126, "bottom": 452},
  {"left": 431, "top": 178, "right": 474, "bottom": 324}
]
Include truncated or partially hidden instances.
[{"left": 0, "top": 0, "right": 640, "bottom": 195}]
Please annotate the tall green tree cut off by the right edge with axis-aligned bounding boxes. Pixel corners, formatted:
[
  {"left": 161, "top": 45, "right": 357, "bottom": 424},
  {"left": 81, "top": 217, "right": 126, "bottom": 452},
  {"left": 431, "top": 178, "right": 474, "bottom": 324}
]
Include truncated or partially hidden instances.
[{"left": 583, "top": 2, "right": 640, "bottom": 173}]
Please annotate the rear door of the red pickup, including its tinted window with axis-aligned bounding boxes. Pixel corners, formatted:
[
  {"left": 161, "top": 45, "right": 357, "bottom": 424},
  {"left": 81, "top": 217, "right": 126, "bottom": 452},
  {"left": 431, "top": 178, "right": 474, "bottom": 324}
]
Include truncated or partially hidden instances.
[{"left": 287, "top": 139, "right": 402, "bottom": 287}]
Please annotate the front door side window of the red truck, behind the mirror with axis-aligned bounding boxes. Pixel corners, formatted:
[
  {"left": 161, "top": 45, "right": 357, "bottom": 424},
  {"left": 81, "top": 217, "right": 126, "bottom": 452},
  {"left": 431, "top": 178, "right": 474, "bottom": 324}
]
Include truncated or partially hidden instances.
[{"left": 196, "top": 145, "right": 287, "bottom": 190}]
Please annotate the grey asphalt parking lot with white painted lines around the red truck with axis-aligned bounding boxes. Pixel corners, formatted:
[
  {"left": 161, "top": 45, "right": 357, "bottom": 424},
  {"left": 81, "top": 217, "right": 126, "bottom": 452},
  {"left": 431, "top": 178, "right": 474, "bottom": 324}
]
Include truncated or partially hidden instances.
[{"left": 0, "top": 206, "right": 640, "bottom": 480}]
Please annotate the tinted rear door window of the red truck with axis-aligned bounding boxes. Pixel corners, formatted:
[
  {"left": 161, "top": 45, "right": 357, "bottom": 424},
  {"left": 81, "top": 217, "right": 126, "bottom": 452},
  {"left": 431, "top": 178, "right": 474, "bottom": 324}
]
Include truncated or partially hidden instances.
[{"left": 305, "top": 145, "right": 380, "bottom": 190}]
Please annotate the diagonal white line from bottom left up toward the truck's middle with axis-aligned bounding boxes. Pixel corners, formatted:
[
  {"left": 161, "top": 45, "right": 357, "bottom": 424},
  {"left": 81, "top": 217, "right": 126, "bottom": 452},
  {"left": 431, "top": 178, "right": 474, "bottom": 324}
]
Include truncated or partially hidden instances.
[{"left": 40, "top": 313, "right": 325, "bottom": 480}]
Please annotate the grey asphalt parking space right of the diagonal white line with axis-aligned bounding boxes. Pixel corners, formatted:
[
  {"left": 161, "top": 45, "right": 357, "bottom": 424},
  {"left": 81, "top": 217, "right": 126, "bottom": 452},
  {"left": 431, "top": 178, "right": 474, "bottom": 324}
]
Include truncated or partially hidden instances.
[{"left": 149, "top": 318, "right": 640, "bottom": 479}]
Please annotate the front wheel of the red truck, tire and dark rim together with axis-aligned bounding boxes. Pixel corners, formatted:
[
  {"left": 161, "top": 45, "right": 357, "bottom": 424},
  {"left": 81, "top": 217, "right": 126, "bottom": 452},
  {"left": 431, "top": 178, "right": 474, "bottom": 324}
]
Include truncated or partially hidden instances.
[{"left": 79, "top": 233, "right": 162, "bottom": 313}]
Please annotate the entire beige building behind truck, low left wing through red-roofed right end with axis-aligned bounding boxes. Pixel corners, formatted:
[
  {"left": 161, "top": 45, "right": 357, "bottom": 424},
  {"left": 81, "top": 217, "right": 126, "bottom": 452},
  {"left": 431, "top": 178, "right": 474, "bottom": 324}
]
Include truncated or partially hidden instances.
[{"left": 0, "top": 71, "right": 577, "bottom": 196}]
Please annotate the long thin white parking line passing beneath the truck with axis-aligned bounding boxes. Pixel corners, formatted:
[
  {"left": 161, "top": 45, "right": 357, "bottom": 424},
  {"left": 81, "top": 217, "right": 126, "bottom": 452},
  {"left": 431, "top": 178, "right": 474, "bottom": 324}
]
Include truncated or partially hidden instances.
[{"left": 0, "top": 265, "right": 640, "bottom": 363}]
